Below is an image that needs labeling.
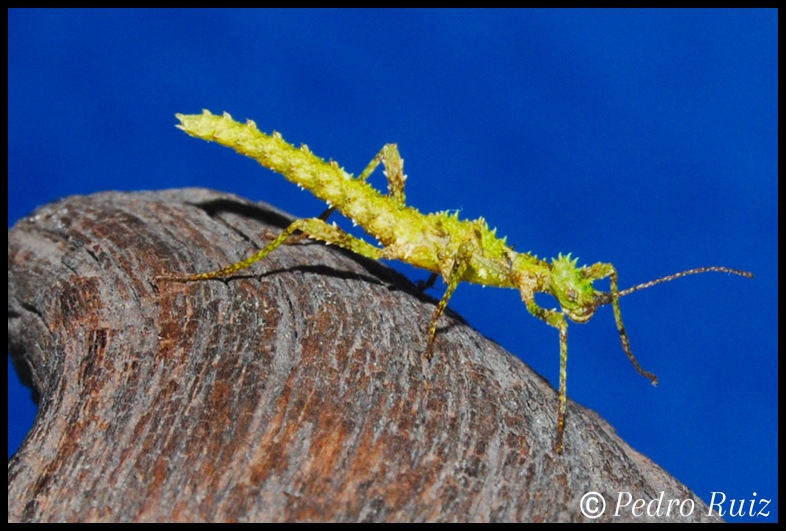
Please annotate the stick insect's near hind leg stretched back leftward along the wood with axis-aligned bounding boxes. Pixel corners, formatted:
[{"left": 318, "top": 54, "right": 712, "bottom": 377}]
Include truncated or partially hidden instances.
[{"left": 156, "top": 218, "right": 382, "bottom": 282}]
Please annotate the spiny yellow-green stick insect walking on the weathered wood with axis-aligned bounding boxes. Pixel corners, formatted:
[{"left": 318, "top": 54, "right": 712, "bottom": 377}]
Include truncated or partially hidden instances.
[{"left": 156, "top": 110, "right": 753, "bottom": 453}]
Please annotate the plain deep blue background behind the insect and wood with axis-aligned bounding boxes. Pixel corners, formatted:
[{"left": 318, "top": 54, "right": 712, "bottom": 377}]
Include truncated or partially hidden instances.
[{"left": 8, "top": 10, "right": 778, "bottom": 521}]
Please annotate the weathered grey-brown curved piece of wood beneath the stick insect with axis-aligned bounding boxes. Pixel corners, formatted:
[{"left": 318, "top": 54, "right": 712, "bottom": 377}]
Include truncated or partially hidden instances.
[{"left": 8, "top": 189, "right": 713, "bottom": 521}]
